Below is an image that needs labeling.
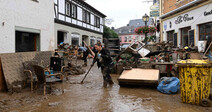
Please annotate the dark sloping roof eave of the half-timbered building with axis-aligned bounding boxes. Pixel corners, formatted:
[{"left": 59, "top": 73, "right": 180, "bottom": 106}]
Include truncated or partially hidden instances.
[{"left": 73, "top": 0, "right": 107, "bottom": 18}]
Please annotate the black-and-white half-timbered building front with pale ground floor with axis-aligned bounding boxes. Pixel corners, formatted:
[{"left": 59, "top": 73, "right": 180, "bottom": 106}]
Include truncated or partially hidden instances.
[{"left": 54, "top": 0, "right": 106, "bottom": 46}]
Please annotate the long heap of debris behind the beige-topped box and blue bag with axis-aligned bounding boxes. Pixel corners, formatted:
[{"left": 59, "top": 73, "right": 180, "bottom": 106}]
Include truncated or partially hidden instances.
[{"left": 113, "top": 42, "right": 210, "bottom": 76}]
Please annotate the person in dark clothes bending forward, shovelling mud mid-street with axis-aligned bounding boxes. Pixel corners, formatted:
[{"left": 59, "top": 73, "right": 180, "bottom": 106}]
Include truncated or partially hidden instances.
[{"left": 91, "top": 42, "right": 113, "bottom": 87}]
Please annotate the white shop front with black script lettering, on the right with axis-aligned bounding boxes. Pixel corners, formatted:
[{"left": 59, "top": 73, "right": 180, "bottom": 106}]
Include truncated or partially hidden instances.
[{"left": 161, "top": 1, "right": 212, "bottom": 47}]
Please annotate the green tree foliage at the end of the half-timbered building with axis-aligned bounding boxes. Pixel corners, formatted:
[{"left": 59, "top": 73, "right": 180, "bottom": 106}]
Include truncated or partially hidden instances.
[{"left": 103, "top": 26, "right": 118, "bottom": 38}]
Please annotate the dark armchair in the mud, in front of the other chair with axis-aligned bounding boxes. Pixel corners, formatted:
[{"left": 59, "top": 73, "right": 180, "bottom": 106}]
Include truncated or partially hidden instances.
[{"left": 33, "top": 65, "right": 64, "bottom": 95}]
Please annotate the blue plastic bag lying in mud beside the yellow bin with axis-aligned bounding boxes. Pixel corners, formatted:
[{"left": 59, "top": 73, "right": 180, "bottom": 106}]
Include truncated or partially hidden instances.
[{"left": 157, "top": 77, "right": 180, "bottom": 94}]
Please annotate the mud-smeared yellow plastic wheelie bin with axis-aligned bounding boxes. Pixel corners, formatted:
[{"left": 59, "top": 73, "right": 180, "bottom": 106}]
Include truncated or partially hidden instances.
[{"left": 177, "top": 60, "right": 212, "bottom": 106}]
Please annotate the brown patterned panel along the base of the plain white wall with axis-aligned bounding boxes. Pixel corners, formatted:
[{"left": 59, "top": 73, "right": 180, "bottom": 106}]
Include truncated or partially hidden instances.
[{"left": 0, "top": 51, "right": 53, "bottom": 92}]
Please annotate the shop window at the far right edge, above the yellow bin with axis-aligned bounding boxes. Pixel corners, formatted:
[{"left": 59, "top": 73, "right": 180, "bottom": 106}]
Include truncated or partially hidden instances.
[{"left": 199, "top": 22, "right": 212, "bottom": 45}]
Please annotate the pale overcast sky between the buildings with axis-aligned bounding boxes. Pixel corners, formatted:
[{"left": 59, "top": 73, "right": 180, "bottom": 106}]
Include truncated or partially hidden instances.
[{"left": 85, "top": 0, "right": 153, "bottom": 28}]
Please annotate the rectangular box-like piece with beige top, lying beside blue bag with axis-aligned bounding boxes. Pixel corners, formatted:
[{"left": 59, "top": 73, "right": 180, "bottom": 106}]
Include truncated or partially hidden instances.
[{"left": 118, "top": 68, "right": 159, "bottom": 86}]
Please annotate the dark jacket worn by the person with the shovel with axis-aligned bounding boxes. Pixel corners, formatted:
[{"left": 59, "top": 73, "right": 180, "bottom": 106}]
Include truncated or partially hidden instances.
[{"left": 93, "top": 48, "right": 112, "bottom": 67}]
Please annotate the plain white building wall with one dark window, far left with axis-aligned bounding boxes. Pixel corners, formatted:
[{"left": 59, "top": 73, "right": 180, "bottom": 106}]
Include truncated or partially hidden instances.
[{"left": 0, "top": 0, "right": 55, "bottom": 53}]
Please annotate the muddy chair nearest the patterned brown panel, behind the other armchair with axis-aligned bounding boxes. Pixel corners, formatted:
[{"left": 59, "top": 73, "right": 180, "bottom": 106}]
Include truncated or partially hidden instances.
[{"left": 23, "top": 61, "right": 38, "bottom": 91}]
